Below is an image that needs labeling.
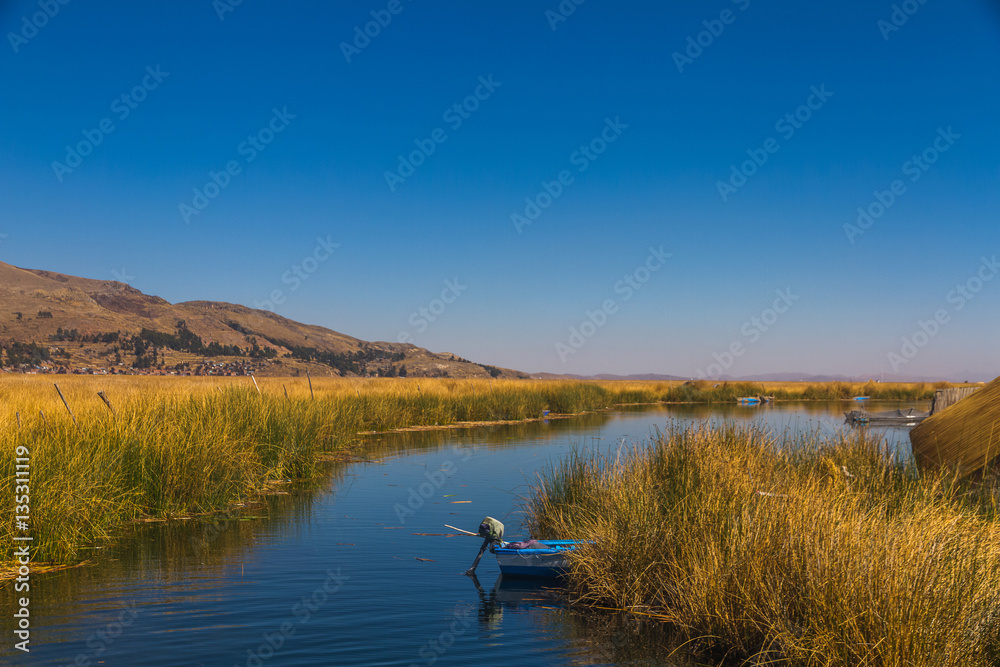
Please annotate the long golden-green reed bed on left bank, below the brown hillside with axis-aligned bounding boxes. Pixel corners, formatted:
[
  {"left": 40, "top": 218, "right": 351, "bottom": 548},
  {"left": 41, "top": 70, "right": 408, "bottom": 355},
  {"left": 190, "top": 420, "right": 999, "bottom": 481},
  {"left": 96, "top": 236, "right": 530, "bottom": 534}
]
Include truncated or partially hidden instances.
[{"left": 0, "top": 374, "right": 952, "bottom": 562}]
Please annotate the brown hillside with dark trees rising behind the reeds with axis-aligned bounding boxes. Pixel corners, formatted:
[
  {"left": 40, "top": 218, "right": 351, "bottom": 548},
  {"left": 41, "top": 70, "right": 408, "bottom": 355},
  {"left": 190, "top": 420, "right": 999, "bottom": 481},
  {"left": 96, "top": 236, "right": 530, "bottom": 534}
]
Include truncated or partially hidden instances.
[{"left": 0, "top": 262, "right": 526, "bottom": 378}]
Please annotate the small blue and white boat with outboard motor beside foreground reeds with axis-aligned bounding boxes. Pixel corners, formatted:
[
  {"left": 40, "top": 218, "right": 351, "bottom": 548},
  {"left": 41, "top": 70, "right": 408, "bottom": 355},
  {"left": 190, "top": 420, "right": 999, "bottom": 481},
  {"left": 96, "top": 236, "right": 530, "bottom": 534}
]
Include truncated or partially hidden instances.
[{"left": 454, "top": 516, "right": 587, "bottom": 578}]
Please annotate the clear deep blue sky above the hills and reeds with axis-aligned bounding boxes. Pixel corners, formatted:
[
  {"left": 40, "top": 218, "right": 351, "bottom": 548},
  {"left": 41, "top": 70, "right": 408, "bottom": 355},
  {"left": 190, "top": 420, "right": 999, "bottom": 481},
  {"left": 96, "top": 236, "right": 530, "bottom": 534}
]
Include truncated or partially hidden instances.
[{"left": 0, "top": 0, "right": 1000, "bottom": 379}]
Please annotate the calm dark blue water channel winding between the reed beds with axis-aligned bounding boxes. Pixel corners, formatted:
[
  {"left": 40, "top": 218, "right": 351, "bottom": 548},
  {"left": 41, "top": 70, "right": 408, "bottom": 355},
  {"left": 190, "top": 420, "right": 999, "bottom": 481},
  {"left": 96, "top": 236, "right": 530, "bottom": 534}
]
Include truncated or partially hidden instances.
[{"left": 0, "top": 403, "right": 927, "bottom": 667}]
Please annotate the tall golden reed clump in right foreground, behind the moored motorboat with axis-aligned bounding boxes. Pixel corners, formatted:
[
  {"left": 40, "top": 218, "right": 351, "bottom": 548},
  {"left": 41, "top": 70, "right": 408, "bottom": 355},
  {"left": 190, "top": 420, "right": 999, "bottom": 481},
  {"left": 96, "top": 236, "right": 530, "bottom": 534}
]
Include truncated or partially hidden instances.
[{"left": 526, "top": 426, "right": 1000, "bottom": 667}]
